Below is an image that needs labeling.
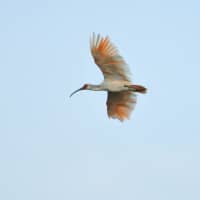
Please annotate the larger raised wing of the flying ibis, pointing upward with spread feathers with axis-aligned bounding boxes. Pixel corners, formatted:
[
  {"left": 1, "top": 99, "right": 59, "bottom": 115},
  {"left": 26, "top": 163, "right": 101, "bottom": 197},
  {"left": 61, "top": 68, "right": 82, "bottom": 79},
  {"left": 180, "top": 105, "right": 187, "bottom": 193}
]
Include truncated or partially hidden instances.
[{"left": 90, "top": 33, "right": 131, "bottom": 82}]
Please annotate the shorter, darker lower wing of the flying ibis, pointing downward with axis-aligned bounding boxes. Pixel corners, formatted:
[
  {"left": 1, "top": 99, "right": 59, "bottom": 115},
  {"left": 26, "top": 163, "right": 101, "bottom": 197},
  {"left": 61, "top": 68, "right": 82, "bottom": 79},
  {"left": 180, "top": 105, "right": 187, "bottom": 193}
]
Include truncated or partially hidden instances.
[{"left": 106, "top": 91, "right": 136, "bottom": 121}]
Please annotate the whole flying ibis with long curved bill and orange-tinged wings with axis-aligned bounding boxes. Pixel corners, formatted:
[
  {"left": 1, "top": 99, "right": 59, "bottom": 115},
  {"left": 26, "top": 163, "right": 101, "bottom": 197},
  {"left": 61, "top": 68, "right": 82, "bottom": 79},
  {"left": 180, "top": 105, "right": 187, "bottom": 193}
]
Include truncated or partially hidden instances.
[{"left": 70, "top": 33, "right": 147, "bottom": 121}]
